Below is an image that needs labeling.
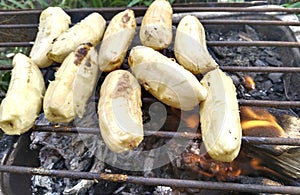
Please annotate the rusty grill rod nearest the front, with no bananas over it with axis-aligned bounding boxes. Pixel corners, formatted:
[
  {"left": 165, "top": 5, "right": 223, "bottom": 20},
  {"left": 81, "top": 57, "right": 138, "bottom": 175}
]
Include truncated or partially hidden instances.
[{"left": 0, "top": 165, "right": 300, "bottom": 194}]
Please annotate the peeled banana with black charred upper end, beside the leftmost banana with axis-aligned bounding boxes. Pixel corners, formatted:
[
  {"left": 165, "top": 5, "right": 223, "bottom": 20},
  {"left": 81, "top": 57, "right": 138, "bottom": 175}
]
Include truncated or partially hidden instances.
[{"left": 43, "top": 43, "right": 98, "bottom": 123}]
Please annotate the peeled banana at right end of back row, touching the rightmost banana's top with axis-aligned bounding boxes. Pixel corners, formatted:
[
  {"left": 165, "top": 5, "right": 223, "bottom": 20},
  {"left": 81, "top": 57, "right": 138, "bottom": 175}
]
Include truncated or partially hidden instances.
[{"left": 174, "top": 15, "right": 218, "bottom": 74}]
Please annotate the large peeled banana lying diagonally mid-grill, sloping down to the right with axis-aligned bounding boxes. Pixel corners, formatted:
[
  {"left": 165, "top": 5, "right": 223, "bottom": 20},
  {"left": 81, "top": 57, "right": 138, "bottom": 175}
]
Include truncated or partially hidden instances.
[{"left": 128, "top": 46, "right": 207, "bottom": 110}]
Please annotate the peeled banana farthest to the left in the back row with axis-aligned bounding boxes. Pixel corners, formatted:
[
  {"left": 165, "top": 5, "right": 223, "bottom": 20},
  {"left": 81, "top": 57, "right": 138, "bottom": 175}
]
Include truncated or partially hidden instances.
[{"left": 29, "top": 7, "right": 71, "bottom": 68}]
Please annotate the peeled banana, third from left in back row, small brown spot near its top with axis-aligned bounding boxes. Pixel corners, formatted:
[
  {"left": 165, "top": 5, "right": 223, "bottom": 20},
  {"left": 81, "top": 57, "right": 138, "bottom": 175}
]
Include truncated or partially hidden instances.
[{"left": 98, "top": 9, "right": 136, "bottom": 72}]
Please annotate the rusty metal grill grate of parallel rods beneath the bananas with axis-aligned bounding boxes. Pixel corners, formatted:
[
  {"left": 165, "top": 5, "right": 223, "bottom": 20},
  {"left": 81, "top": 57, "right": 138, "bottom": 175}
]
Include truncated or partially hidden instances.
[{"left": 0, "top": 4, "right": 300, "bottom": 194}]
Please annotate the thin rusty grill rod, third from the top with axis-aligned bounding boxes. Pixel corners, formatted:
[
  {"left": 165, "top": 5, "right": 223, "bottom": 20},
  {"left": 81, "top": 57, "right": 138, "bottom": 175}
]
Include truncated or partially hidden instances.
[{"left": 0, "top": 41, "right": 300, "bottom": 47}]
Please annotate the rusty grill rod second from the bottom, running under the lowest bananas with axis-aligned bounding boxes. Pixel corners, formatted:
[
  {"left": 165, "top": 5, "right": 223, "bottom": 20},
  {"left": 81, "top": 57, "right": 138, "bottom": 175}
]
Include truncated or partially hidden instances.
[{"left": 31, "top": 125, "right": 300, "bottom": 146}]
